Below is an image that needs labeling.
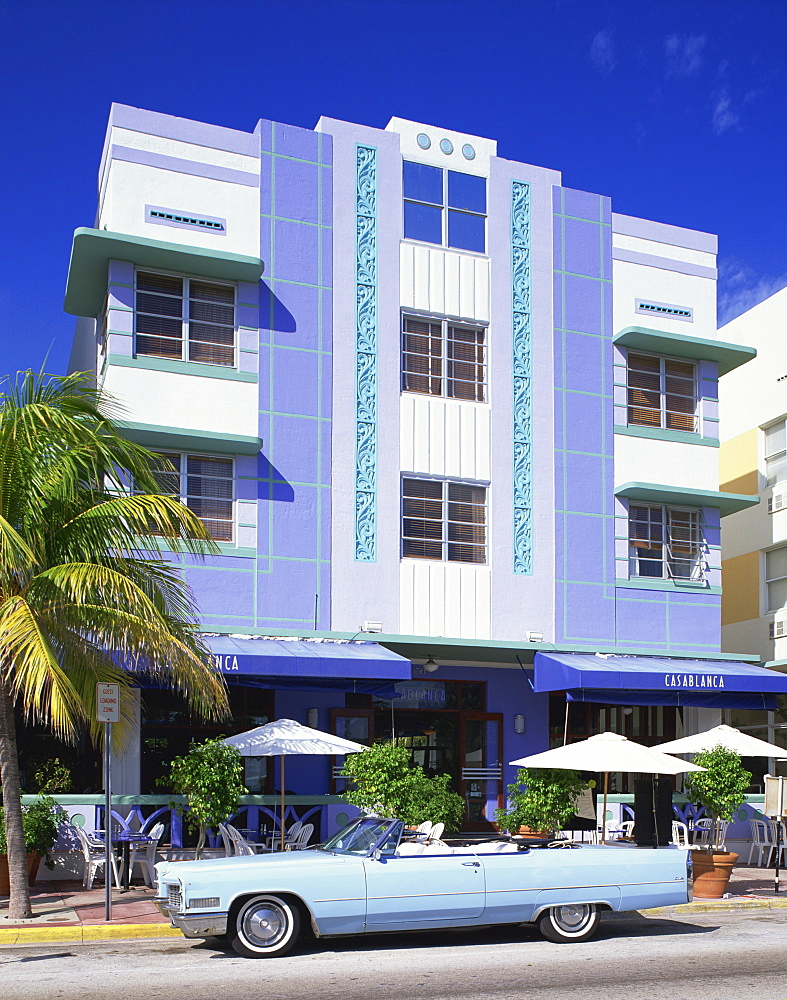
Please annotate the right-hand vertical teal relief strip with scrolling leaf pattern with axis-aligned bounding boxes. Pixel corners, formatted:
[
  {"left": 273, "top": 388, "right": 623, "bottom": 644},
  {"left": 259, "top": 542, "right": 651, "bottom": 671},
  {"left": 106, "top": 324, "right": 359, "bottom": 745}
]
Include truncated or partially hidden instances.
[{"left": 511, "top": 181, "right": 533, "bottom": 574}]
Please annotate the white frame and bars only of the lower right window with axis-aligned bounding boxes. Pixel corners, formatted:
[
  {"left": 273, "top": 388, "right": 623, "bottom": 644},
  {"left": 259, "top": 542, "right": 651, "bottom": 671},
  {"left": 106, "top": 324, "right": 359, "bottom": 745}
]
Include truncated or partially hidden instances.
[{"left": 628, "top": 503, "right": 706, "bottom": 583}]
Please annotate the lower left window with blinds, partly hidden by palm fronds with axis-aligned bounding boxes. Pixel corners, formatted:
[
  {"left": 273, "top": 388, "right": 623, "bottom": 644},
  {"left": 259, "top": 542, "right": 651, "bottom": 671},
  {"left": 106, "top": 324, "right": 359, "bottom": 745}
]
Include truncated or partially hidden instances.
[{"left": 153, "top": 453, "right": 235, "bottom": 542}]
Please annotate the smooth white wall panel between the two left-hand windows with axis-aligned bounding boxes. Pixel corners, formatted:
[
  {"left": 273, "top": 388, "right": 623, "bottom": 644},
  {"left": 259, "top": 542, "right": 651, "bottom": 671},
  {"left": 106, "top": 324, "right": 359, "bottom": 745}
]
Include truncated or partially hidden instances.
[{"left": 104, "top": 365, "right": 259, "bottom": 437}]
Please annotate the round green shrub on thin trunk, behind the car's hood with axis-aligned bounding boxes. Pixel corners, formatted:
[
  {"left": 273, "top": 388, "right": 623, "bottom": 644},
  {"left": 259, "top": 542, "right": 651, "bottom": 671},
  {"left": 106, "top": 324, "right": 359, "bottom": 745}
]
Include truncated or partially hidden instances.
[{"left": 158, "top": 737, "right": 246, "bottom": 858}]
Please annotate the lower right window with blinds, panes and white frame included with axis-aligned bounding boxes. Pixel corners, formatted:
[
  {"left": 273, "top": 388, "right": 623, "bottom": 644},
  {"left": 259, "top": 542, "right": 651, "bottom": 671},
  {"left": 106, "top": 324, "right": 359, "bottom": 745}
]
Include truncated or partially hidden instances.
[{"left": 629, "top": 505, "right": 705, "bottom": 581}]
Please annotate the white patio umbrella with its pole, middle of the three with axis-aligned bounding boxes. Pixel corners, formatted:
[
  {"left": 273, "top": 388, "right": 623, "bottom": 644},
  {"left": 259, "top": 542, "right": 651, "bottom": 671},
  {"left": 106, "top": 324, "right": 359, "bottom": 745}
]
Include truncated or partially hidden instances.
[{"left": 510, "top": 733, "right": 705, "bottom": 844}]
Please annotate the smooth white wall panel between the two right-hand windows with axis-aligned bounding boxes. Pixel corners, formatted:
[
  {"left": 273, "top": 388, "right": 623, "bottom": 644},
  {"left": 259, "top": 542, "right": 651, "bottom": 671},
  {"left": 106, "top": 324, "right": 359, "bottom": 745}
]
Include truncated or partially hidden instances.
[{"left": 615, "top": 434, "right": 719, "bottom": 491}]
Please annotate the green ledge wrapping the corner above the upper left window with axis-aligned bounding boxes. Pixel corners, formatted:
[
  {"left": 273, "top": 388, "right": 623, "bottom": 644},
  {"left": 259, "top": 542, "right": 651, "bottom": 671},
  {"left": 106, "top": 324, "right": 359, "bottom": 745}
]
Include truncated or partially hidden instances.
[{"left": 64, "top": 229, "right": 265, "bottom": 316}]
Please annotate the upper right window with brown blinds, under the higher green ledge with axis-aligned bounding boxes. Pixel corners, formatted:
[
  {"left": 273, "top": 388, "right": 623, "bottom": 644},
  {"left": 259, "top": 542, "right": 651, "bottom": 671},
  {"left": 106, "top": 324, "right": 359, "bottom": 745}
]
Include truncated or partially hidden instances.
[{"left": 628, "top": 351, "right": 698, "bottom": 433}]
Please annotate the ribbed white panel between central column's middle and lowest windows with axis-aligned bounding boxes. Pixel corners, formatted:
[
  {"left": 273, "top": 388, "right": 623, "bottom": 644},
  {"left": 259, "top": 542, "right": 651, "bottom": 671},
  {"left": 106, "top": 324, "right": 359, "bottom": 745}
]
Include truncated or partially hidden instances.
[{"left": 400, "top": 393, "right": 491, "bottom": 483}]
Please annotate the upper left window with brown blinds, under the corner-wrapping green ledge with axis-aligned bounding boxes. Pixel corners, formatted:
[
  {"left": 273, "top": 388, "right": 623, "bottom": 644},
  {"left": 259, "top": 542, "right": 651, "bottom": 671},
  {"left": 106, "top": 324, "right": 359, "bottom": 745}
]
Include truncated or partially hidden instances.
[{"left": 135, "top": 271, "right": 235, "bottom": 367}]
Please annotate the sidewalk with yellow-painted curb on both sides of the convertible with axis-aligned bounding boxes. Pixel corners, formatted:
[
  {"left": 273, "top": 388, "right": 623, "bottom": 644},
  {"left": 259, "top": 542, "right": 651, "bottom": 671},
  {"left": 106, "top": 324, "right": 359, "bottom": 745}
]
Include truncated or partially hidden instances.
[{"left": 0, "top": 865, "right": 787, "bottom": 946}]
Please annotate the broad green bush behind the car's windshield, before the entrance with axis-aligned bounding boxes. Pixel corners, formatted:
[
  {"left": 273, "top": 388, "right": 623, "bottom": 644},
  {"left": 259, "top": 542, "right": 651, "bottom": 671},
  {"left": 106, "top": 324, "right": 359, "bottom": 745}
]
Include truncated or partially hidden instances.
[{"left": 341, "top": 743, "right": 465, "bottom": 831}]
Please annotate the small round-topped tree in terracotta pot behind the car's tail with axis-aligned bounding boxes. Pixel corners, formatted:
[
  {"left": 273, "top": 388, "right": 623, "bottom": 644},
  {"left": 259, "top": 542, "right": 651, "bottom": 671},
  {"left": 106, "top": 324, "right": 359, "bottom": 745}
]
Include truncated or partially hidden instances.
[{"left": 685, "top": 746, "right": 751, "bottom": 899}]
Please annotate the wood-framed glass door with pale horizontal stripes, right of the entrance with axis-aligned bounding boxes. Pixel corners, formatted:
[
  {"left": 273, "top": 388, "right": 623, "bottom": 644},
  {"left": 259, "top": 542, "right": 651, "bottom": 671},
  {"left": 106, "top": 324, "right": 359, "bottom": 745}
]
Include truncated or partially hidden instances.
[{"left": 459, "top": 712, "right": 503, "bottom": 830}]
